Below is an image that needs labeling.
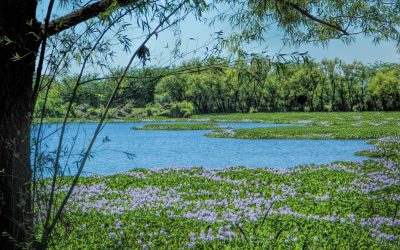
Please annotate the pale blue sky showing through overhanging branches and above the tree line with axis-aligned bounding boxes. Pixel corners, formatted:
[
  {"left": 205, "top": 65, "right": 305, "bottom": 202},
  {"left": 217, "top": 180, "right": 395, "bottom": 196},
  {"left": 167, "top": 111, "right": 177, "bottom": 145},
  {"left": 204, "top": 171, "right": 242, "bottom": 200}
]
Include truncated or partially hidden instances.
[{"left": 38, "top": 1, "right": 400, "bottom": 70}]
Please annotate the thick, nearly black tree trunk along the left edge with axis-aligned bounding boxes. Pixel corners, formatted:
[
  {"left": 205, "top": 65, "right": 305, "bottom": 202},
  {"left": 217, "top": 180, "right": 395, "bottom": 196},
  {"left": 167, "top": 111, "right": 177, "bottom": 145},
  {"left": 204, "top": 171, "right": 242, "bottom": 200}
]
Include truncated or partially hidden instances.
[{"left": 0, "top": 0, "right": 39, "bottom": 249}]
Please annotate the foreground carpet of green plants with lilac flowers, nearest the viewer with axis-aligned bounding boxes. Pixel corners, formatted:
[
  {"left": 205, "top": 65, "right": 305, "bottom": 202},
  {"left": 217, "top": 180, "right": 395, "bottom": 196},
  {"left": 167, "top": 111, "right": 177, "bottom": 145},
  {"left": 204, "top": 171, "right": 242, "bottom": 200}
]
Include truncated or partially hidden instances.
[{"left": 41, "top": 138, "right": 400, "bottom": 249}]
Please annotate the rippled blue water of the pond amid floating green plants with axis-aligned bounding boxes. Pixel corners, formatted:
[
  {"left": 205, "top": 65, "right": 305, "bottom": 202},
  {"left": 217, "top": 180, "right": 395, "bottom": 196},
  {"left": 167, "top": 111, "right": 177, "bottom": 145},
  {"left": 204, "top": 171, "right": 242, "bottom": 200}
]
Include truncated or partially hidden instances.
[{"left": 32, "top": 122, "right": 371, "bottom": 175}]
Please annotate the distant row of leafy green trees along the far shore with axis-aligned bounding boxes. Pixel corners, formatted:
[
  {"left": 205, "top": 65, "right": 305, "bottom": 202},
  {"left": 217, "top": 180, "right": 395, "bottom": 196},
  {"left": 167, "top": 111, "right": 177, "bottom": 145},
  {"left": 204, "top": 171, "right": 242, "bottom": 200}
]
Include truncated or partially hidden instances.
[{"left": 38, "top": 57, "right": 400, "bottom": 118}]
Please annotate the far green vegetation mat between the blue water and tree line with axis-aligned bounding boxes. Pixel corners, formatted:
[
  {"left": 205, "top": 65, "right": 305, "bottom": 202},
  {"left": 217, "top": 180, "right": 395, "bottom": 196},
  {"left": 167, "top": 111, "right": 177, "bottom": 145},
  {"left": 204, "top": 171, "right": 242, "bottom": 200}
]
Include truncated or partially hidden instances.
[{"left": 205, "top": 112, "right": 400, "bottom": 139}]
